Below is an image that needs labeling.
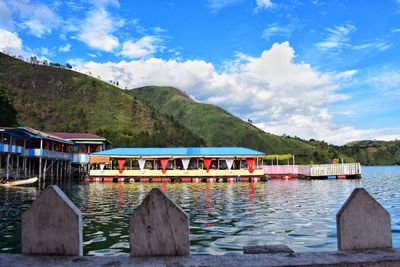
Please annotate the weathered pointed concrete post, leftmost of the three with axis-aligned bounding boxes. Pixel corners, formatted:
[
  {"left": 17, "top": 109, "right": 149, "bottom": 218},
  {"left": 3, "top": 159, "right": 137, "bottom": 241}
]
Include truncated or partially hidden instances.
[{"left": 22, "top": 185, "right": 82, "bottom": 256}]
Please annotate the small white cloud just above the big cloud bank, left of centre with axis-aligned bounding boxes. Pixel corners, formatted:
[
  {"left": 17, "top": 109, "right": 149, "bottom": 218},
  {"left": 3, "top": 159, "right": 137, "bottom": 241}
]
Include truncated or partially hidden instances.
[{"left": 119, "top": 35, "right": 162, "bottom": 58}]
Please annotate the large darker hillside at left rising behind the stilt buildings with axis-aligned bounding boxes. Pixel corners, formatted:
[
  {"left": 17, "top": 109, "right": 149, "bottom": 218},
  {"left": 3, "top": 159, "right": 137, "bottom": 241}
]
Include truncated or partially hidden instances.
[{"left": 0, "top": 53, "right": 204, "bottom": 149}]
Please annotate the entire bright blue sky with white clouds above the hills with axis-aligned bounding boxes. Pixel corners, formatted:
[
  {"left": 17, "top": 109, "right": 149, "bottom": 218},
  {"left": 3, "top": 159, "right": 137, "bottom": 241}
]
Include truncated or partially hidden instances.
[{"left": 0, "top": 0, "right": 400, "bottom": 144}]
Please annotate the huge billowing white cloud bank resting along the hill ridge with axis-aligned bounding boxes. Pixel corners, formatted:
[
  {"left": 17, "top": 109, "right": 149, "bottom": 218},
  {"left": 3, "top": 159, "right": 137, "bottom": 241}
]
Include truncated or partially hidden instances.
[{"left": 73, "top": 42, "right": 390, "bottom": 144}]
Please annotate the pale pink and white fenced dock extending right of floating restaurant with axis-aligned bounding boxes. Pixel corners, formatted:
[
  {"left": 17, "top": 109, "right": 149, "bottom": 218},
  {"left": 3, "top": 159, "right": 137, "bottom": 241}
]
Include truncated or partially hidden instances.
[{"left": 263, "top": 163, "right": 361, "bottom": 179}]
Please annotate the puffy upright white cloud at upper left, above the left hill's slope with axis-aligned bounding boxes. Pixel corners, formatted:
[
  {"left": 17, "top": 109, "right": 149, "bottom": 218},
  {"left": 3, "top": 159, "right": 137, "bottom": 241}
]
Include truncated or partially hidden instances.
[{"left": 79, "top": 8, "right": 122, "bottom": 52}]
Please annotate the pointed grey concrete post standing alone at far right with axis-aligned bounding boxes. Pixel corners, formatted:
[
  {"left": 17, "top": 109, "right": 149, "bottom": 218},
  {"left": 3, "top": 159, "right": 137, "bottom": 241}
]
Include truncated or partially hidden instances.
[{"left": 336, "top": 188, "right": 392, "bottom": 250}]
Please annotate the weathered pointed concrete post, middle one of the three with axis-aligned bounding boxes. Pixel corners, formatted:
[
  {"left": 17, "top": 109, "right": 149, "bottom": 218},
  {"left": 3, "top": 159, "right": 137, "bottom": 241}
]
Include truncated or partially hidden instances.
[{"left": 129, "top": 188, "right": 190, "bottom": 257}]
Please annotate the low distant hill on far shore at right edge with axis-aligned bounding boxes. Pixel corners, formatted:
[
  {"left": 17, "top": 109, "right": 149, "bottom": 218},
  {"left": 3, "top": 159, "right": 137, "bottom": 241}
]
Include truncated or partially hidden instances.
[{"left": 339, "top": 140, "right": 400, "bottom": 165}]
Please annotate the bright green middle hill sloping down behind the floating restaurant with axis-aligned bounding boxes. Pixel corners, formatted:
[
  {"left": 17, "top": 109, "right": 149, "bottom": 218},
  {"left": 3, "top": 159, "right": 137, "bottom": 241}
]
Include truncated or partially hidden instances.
[{"left": 130, "top": 86, "right": 352, "bottom": 163}]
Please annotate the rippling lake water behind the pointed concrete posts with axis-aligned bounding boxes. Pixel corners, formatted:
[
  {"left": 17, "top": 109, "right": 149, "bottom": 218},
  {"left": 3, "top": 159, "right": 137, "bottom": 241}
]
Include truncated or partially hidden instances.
[{"left": 0, "top": 166, "right": 400, "bottom": 255}]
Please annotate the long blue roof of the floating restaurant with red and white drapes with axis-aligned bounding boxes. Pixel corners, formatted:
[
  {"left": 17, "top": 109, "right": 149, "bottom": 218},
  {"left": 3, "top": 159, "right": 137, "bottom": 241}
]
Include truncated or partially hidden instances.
[{"left": 92, "top": 147, "right": 265, "bottom": 157}]
